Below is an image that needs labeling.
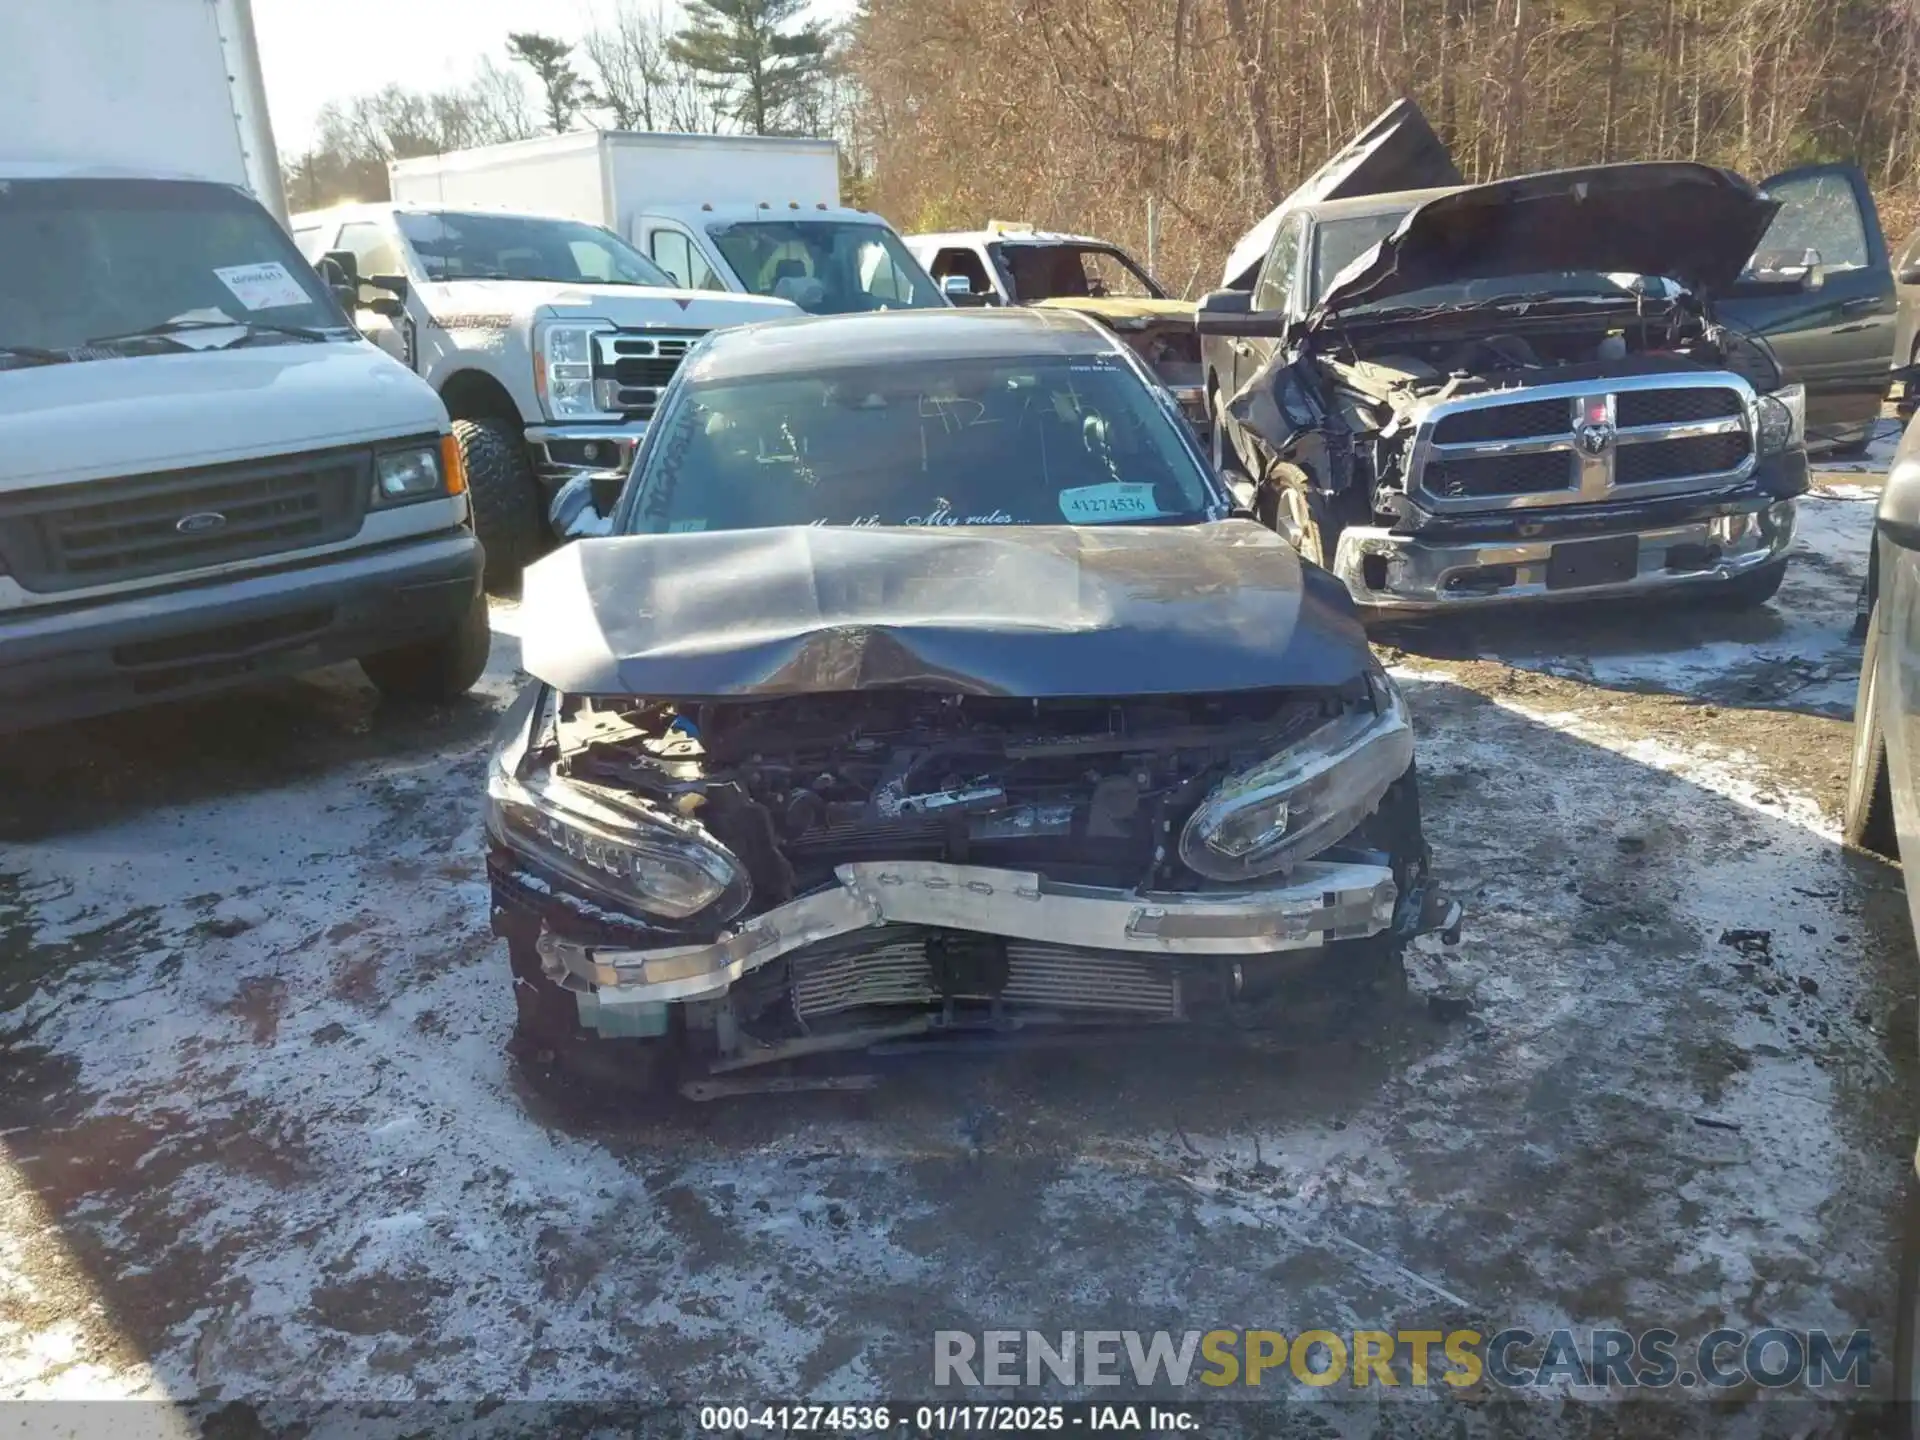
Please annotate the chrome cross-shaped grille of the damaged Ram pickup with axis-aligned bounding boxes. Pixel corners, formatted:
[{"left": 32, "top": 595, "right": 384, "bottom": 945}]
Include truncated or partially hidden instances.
[{"left": 1407, "top": 372, "right": 1755, "bottom": 515}]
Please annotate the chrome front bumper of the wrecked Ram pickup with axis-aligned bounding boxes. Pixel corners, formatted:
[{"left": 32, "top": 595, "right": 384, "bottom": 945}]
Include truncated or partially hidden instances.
[{"left": 1332, "top": 499, "right": 1793, "bottom": 612}]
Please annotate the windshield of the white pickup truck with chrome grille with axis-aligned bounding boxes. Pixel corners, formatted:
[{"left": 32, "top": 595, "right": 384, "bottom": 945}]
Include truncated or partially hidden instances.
[{"left": 394, "top": 211, "right": 674, "bottom": 288}]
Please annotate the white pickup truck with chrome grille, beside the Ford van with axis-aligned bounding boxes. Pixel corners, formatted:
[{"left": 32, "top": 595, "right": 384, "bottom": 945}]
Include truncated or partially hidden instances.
[{"left": 294, "top": 204, "right": 799, "bottom": 589}]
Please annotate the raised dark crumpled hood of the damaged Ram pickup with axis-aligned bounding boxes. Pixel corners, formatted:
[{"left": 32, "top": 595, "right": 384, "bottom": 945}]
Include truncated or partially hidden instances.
[{"left": 1313, "top": 161, "right": 1780, "bottom": 323}]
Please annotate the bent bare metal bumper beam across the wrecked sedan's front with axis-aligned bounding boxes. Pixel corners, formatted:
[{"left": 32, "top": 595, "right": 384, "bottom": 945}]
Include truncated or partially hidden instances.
[{"left": 538, "top": 860, "right": 1405, "bottom": 1014}]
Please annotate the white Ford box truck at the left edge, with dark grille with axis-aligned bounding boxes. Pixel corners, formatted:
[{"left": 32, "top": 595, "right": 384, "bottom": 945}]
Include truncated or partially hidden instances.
[{"left": 0, "top": 0, "right": 490, "bottom": 730}]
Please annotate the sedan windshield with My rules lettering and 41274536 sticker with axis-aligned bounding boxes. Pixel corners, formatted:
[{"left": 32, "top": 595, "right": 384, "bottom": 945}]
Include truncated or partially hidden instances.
[{"left": 628, "top": 355, "right": 1215, "bottom": 534}]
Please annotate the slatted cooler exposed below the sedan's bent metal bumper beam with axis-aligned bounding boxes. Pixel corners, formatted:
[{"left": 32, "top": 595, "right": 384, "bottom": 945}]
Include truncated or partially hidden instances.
[{"left": 787, "top": 925, "right": 1181, "bottom": 1021}]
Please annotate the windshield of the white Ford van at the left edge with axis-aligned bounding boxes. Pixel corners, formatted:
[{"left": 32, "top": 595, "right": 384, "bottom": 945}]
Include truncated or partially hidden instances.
[{"left": 0, "top": 179, "right": 348, "bottom": 359}]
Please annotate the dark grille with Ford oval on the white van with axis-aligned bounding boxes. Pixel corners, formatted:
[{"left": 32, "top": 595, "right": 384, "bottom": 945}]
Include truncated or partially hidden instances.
[{"left": 0, "top": 451, "right": 372, "bottom": 593}]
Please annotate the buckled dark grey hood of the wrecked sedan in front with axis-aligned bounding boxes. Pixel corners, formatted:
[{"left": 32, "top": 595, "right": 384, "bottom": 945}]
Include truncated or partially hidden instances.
[{"left": 520, "top": 520, "right": 1373, "bottom": 699}]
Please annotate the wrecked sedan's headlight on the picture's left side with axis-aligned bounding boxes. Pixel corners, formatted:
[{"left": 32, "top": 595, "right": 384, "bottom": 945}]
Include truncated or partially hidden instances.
[{"left": 488, "top": 725, "right": 753, "bottom": 920}]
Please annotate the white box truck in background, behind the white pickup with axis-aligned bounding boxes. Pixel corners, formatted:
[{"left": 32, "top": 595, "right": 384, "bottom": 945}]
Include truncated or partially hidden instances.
[{"left": 390, "top": 131, "right": 947, "bottom": 315}]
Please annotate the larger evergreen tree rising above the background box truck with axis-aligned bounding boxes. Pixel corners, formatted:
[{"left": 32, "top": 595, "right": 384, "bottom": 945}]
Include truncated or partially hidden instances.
[{"left": 668, "top": 0, "right": 828, "bottom": 134}]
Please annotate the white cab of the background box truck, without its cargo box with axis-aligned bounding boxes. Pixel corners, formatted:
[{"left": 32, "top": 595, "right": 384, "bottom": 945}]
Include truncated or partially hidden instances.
[{"left": 634, "top": 202, "right": 948, "bottom": 315}]
